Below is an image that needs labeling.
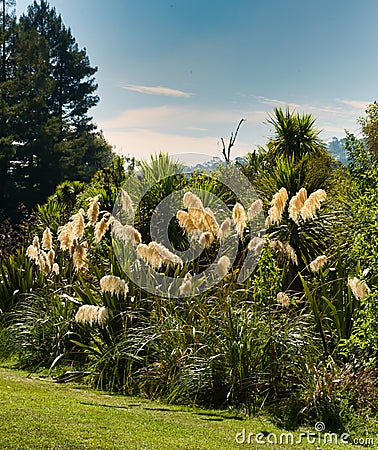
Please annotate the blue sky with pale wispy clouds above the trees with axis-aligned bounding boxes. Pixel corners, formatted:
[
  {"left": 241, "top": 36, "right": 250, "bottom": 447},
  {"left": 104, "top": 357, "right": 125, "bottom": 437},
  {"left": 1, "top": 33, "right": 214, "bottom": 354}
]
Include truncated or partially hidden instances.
[{"left": 17, "top": 0, "right": 378, "bottom": 162}]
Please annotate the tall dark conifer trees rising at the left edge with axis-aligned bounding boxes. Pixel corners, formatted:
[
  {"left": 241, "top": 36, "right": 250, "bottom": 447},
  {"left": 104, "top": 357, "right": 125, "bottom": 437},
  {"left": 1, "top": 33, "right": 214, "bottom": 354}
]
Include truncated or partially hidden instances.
[{"left": 0, "top": 0, "right": 112, "bottom": 220}]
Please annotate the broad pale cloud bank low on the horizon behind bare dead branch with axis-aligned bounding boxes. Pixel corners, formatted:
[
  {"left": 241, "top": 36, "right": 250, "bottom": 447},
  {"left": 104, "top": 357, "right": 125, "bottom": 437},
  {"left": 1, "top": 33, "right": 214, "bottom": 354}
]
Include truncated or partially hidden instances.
[{"left": 98, "top": 105, "right": 266, "bottom": 158}]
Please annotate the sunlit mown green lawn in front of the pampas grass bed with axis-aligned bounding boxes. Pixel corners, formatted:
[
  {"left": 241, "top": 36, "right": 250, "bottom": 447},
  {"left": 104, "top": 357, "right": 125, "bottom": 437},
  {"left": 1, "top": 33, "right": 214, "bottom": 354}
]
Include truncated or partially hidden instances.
[{"left": 0, "top": 368, "right": 374, "bottom": 450}]
